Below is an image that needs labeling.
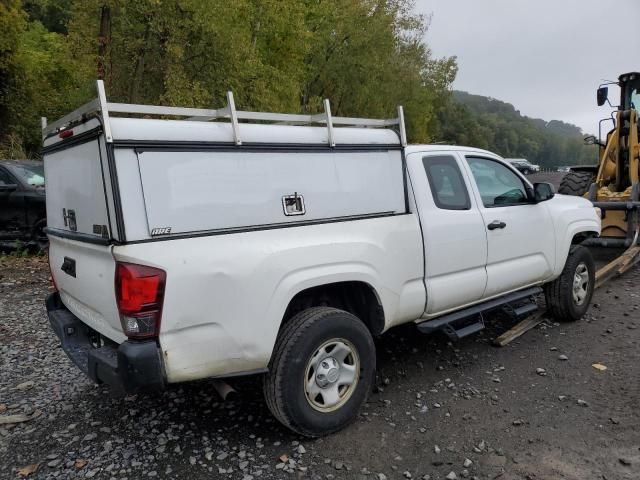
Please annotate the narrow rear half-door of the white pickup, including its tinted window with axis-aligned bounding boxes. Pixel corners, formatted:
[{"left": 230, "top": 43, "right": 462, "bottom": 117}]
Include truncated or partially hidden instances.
[{"left": 407, "top": 151, "right": 487, "bottom": 315}]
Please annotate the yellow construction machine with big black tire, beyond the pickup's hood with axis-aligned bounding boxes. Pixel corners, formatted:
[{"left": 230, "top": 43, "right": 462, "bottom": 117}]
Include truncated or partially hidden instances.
[{"left": 558, "top": 72, "right": 640, "bottom": 251}]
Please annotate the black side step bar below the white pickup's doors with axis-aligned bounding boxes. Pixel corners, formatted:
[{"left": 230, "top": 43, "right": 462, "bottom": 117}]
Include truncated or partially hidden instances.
[{"left": 418, "top": 287, "right": 542, "bottom": 340}]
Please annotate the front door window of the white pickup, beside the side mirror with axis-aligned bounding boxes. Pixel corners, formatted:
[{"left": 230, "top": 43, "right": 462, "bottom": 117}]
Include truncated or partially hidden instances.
[{"left": 467, "top": 157, "right": 529, "bottom": 207}]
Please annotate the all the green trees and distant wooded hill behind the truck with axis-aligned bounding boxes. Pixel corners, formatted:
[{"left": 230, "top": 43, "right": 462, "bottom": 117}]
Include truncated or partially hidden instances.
[{"left": 0, "top": 0, "right": 595, "bottom": 166}]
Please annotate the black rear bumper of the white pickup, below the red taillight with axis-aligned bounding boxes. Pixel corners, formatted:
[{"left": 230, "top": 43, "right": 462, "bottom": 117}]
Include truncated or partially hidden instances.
[{"left": 46, "top": 292, "right": 165, "bottom": 393}]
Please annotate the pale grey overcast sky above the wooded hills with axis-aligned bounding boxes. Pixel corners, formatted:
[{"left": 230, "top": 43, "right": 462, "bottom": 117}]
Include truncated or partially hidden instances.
[{"left": 415, "top": 0, "right": 640, "bottom": 133}]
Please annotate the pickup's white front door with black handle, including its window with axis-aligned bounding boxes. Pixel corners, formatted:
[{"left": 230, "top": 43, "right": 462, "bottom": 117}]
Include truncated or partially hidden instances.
[{"left": 466, "top": 155, "right": 556, "bottom": 298}]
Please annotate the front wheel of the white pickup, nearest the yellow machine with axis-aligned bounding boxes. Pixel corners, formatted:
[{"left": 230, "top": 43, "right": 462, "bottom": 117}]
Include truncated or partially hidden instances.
[{"left": 544, "top": 245, "right": 596, "bottom": 322}]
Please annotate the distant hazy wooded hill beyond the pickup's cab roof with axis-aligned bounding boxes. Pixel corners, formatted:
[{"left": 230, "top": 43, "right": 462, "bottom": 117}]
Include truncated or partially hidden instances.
[{"left": 432, "top": 91, "right": 598, "bottom": 167}]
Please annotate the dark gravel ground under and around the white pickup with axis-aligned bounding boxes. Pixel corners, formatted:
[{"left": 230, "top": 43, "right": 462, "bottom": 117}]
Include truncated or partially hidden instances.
[{"left": 0, "top": 253, "right": 640, "bottom": 480}]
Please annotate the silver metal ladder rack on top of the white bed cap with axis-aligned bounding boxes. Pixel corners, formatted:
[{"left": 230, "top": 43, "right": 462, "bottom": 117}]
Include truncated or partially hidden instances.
[{"left": 42, "top": 80, "right": 407, "bottom": 147}]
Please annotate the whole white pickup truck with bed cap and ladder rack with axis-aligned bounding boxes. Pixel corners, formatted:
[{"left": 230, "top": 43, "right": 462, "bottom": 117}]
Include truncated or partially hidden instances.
[{"left": 43, "top": 82, "right": 600, "bottom": 436}]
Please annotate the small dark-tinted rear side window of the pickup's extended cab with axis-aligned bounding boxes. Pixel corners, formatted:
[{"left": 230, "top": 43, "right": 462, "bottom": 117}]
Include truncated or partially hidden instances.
[{"left": 422, "top": 155, "right": 471, "bottom": 210}]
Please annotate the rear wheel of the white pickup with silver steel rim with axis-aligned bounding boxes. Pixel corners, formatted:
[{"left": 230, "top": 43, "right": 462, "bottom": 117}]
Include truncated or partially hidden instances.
[{"left": 263, "top": 307, "right": 376, "bottom": 437}]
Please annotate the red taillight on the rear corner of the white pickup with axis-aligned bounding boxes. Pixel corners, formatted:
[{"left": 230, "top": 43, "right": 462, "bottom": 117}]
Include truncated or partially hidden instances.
[{"left": 116, "top": 262, "right": 166, "bottom": 338}]
